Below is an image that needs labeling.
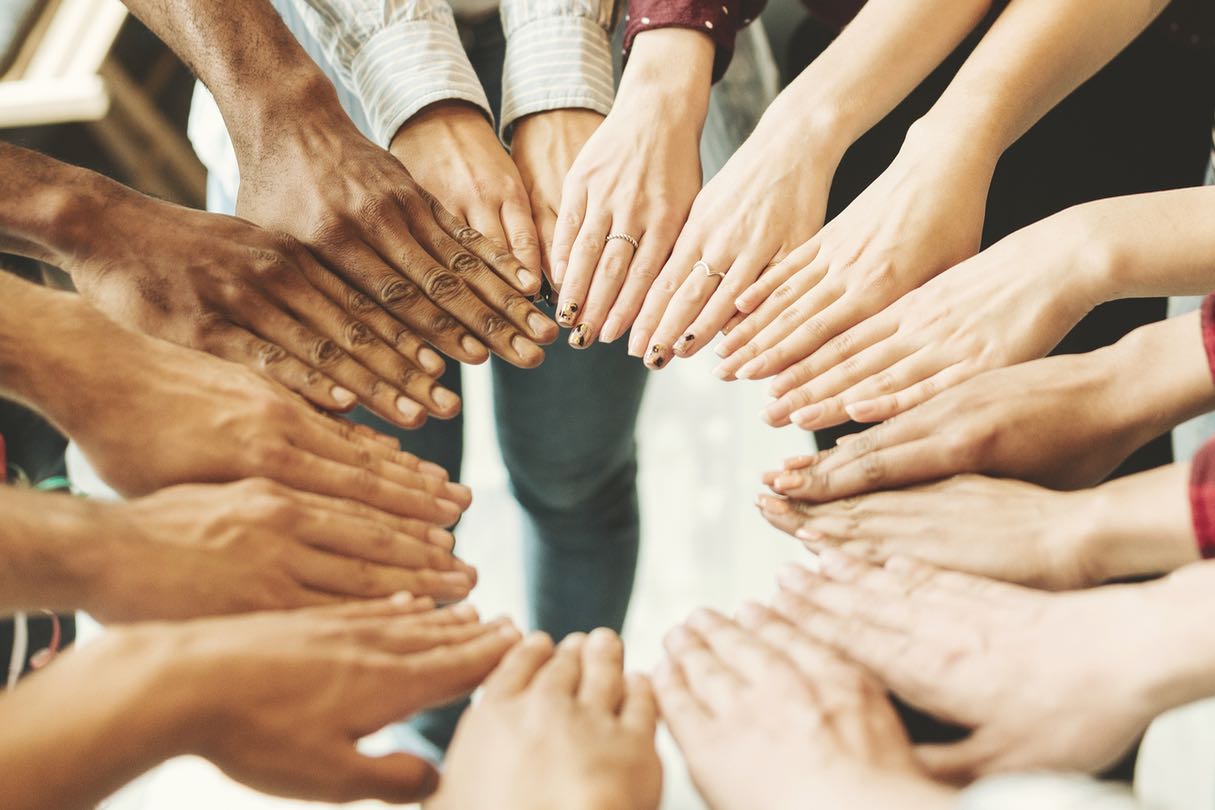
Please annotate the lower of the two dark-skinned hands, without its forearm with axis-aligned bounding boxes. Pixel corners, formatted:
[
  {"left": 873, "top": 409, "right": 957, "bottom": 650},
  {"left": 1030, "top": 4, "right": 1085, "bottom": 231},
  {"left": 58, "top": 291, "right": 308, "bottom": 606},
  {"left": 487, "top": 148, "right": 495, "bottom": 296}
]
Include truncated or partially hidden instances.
[{"left": 63, "top": 182, "right": 459, "bottom": 427}]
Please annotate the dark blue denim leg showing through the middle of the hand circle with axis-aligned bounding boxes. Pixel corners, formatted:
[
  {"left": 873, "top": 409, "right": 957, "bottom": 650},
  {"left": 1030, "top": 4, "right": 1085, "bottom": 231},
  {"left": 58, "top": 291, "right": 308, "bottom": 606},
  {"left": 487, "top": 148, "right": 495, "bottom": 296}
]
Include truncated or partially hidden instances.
[{"left": 493, "top": 315, "right": 646, "bottom": 639}]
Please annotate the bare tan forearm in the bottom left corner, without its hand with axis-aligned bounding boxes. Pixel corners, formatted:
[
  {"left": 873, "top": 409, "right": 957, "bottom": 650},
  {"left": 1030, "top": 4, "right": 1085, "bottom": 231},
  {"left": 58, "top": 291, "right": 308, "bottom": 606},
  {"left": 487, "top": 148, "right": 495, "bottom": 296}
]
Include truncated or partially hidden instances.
[{"left": 0, "top": 630, "right": 187, "bottom": 810}]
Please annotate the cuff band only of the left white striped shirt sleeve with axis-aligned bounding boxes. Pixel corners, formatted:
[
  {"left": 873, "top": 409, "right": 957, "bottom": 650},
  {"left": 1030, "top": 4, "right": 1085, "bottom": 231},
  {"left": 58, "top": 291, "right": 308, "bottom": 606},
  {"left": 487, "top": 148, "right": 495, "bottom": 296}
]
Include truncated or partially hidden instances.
[{"left": 351, "top": 7, "right": 493, "bottom": 148}]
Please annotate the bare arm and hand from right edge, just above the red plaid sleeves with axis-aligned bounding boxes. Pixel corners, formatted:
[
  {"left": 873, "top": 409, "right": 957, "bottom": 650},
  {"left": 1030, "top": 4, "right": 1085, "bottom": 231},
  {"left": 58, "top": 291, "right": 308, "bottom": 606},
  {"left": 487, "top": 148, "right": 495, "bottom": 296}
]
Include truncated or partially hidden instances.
[{"left": 722, "top": 188, "right": 1215, "bottom": 424}]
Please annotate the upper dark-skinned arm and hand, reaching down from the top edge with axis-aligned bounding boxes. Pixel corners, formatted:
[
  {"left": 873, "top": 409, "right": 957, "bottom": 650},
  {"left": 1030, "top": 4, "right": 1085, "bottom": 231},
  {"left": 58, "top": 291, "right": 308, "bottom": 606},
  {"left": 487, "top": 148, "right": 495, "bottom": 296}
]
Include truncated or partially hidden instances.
[{"left": 117, "top": 0, "right": 556, "bottom": 367}]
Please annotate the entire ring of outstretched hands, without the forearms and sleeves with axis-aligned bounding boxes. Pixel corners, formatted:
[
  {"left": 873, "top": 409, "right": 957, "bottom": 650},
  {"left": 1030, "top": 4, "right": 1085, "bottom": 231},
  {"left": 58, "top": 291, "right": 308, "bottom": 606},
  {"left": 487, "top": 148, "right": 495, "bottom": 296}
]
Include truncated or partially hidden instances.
[{"left": 39, "top": 72, "right": 1205, "bottom": 809}]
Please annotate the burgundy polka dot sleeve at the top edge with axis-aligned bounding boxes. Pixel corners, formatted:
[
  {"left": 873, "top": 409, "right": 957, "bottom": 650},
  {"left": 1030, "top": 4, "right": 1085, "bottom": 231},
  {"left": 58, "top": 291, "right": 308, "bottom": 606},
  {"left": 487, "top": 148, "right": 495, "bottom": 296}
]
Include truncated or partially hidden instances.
[{"left": 625, "top": 0, "right": 767, "bottom": 81}]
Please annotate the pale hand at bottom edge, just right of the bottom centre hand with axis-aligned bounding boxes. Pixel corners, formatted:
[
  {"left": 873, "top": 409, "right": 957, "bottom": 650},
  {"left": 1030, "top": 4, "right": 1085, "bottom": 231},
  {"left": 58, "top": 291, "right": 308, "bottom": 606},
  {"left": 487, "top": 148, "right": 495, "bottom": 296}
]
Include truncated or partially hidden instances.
[{"left": 655, "top": 605, "right": 950, "bottom": 810}]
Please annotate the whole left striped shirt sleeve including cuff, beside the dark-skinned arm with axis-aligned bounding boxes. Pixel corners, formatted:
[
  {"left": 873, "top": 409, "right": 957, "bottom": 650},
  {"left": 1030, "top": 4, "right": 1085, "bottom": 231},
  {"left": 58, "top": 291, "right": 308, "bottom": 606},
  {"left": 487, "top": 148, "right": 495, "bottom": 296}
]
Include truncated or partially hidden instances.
[{"left": 289, "top": 0, "right": 493, "bottom": 147}]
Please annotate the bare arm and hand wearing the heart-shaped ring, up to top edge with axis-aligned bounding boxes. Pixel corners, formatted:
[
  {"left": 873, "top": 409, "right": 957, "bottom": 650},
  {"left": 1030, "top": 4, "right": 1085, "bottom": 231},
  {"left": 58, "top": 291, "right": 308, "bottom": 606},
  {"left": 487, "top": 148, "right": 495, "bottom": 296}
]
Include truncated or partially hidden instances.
[{"left": 628, "top": 0, "right": 990, "bottom": 368}]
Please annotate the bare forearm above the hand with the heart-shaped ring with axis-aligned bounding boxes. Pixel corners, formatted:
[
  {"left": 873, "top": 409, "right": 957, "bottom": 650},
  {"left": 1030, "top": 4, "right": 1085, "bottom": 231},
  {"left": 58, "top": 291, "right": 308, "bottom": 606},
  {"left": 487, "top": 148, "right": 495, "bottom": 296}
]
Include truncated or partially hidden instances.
[{"left": 761, "top": 0, "right": 991, "bottom": 149}]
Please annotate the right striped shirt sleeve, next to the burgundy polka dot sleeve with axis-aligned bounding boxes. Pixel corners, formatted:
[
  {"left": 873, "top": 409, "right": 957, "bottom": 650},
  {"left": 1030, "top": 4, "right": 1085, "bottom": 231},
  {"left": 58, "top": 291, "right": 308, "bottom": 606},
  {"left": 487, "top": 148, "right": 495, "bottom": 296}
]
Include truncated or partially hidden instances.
[{"left": 502, "top": 0, "right": 615, "bottom": 141}]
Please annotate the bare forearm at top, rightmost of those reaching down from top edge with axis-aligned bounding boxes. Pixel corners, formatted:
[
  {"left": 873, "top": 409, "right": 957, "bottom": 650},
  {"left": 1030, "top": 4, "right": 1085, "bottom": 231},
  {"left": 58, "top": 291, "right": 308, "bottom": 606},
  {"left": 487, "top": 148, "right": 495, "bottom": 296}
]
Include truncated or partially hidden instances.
[{"left": 915, "top": 0, "right": 1168, "bottom": 157}]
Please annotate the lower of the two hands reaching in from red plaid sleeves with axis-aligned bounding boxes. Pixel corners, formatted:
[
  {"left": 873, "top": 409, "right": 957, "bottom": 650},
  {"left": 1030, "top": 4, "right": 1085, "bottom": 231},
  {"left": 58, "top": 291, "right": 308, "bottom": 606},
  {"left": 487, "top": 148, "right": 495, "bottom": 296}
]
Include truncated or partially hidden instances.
[{"left": 759, "top": 475, "right": 1103, "bottom": 589}]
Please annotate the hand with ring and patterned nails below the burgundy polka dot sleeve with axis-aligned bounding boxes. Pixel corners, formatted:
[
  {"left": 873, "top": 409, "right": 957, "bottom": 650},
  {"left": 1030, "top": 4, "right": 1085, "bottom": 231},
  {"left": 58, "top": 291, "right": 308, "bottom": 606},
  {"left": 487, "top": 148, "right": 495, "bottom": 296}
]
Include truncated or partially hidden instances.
[{"left": 544, "top": 28, "right": 713, "bottom": 349}]
